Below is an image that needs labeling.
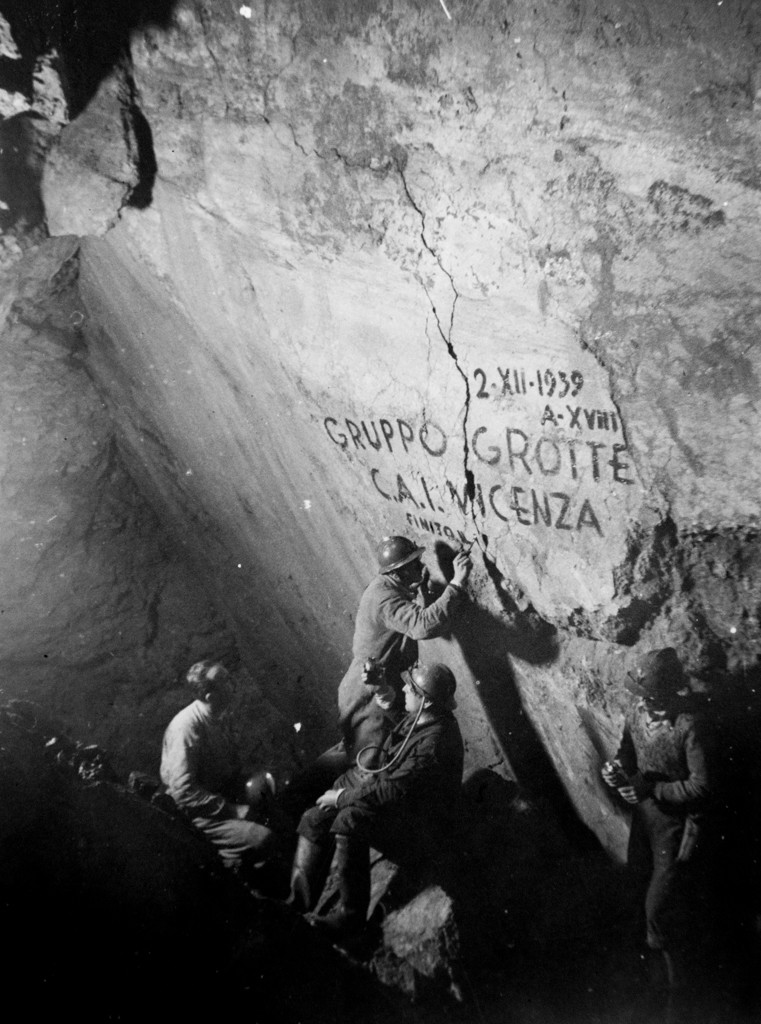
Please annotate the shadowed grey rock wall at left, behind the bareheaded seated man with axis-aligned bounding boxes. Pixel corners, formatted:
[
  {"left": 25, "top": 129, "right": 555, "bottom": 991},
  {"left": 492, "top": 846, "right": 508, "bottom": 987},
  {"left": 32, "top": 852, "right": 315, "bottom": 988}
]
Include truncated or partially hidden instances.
[{"left": 0, "top": 237, "right": 303, "bottom": 771}]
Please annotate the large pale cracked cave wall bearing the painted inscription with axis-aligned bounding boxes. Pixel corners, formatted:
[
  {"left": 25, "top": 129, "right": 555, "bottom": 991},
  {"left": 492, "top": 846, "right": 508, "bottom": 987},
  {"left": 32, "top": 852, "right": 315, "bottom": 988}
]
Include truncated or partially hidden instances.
[{"left": 19, "top": 0, "right": 761, "bottom": 850}]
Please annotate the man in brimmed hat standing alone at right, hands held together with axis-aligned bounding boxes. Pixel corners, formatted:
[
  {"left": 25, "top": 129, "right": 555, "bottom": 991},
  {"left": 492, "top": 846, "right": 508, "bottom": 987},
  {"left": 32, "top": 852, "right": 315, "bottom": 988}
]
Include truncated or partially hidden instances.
[{"left": 602, "top": 647, "right": 714, "bottom": 988}]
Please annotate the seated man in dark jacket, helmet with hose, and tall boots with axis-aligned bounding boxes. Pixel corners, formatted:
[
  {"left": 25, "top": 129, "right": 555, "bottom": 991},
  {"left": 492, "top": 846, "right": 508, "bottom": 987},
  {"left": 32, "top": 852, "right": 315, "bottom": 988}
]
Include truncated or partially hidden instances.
[{"left": 290, "top": 665, "right": 463, "bottom": 935}]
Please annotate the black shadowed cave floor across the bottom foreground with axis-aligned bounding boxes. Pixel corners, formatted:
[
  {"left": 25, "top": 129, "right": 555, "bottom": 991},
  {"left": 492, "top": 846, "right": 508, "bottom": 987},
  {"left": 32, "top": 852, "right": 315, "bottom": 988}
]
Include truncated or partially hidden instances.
[{"left": 0, "top": 708, "right": 761, "bottom": 1024}]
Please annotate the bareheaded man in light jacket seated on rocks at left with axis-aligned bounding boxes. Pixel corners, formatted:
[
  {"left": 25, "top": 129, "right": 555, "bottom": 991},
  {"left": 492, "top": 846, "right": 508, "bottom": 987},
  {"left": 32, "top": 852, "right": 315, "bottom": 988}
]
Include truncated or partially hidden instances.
[{"left": 161, "top": 660, "right": 279, "bottom": 869}]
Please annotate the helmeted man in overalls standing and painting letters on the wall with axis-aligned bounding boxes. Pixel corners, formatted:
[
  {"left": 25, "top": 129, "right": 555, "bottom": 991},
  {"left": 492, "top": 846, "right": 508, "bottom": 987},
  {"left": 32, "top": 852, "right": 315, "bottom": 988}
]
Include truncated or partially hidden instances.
[{"left": 338, "top": 537, "right": 471, "bottom": 767}]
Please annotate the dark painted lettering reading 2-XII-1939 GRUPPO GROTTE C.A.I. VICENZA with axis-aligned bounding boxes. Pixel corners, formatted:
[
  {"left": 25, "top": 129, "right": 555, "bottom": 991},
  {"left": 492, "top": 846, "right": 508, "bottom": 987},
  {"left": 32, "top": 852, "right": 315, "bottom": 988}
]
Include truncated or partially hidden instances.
[{"left": 323, "top": 352, "right": 636, "bottom": 540}]
